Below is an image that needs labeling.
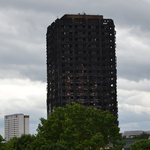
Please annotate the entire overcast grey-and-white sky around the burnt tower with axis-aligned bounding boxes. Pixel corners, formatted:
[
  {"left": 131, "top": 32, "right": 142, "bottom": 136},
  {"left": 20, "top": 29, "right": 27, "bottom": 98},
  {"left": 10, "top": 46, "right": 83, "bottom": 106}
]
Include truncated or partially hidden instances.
[{"left": 0, "top": 0, "right": 150, "bottom": 135}]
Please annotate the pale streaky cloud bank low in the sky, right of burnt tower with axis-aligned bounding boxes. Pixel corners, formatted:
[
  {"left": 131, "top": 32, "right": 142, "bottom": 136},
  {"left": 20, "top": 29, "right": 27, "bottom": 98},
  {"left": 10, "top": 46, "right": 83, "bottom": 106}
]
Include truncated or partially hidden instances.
[{"left": 118, "top": 78, "right": 150, "bottom": 131}]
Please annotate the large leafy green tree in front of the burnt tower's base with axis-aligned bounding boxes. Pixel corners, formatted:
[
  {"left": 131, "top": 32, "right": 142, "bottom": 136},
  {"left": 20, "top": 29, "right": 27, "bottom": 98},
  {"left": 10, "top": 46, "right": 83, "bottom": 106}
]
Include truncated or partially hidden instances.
[{"left": 34, "top": 103, "right": 122, "bottom": 150}]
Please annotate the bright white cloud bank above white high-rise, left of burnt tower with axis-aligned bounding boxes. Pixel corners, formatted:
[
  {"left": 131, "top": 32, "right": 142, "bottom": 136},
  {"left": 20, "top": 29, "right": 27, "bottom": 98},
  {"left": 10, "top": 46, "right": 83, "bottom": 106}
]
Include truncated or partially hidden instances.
[{"left": 0, "top": 78, "right": 46, "bottom": 137}]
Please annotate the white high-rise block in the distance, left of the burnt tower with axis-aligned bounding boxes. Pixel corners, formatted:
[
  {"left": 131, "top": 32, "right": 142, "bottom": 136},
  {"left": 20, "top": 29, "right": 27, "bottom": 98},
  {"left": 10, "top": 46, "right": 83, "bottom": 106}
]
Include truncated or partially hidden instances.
[{"left": 4, "top": 114, "right": 29, "bottom": 141}]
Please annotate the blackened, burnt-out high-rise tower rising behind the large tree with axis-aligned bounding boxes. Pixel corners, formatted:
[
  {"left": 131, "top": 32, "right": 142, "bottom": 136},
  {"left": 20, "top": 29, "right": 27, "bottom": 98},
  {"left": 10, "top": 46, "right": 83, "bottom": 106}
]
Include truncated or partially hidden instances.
[{"left": 47, "top": 14, "right": 118, "bottom": 119}]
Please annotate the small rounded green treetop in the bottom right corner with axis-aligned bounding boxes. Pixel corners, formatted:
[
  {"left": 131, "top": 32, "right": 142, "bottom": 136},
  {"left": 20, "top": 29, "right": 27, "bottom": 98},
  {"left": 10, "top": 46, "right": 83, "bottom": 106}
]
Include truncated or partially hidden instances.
[{"left": 130, "top": 139, "right": 150, "bottom": 150}]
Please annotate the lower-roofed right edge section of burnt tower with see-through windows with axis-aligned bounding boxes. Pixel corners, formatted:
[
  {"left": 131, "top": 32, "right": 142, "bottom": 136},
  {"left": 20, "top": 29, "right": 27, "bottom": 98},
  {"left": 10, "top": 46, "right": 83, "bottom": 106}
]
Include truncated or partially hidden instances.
[{"left": 102, "top": 19, "right": 118, "bottom": 117}]
